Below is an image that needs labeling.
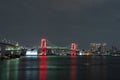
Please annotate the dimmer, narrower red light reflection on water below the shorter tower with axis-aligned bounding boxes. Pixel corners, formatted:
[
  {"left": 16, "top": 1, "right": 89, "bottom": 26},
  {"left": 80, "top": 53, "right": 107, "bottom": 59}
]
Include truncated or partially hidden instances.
[{"left": 70, "top": 56, "right": 77, "bottom": 80}]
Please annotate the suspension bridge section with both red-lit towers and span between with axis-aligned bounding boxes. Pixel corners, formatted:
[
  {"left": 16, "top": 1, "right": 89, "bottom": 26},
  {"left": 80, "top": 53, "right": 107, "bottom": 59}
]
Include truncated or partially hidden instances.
[{"left": 38, "top": 38, "right": 77, "bottom": 56}]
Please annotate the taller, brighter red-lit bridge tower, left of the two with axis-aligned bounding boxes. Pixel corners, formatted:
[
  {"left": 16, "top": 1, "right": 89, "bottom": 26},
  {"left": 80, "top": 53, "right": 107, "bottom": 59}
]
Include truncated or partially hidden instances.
[{"left": 40, "top": 38, "right": 47, "bottom": 56}]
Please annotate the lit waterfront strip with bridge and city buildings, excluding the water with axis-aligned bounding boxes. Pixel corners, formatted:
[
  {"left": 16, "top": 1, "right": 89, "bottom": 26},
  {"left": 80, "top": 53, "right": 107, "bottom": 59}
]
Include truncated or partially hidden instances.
[{"left": 0, "top": 38, "right": 120, "bottom": 60}]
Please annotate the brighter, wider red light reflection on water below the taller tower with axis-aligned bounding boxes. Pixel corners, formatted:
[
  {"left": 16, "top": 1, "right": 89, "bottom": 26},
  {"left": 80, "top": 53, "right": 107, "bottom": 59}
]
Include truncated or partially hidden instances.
[{"left": 39, "top": 56, "right": 47, "bottom": 80}]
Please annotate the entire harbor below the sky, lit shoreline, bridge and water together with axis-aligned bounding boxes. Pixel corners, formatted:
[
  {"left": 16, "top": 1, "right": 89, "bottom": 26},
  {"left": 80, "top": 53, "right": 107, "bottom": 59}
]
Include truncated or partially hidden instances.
[{"left": 0, "top": 38, "right": 120, "bottom": 80}]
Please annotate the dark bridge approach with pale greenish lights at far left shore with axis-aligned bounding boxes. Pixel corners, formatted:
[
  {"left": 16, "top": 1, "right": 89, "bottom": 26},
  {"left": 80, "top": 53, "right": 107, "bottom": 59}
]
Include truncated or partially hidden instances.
[{"left": 0, "top": 41, "right": 22, "bottom": 58}]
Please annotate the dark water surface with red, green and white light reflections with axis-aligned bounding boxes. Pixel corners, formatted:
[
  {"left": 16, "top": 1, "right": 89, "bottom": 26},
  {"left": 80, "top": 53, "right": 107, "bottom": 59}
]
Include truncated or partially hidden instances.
[{"left": 0, "top": 56, "right": 120, "bottom": 80}]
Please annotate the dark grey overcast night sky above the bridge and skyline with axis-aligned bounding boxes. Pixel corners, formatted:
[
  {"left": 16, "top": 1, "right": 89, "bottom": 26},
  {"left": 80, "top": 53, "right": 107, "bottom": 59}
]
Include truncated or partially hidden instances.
[{"left": 0, "top": 0, "right": 120, "bottom": 48}]
